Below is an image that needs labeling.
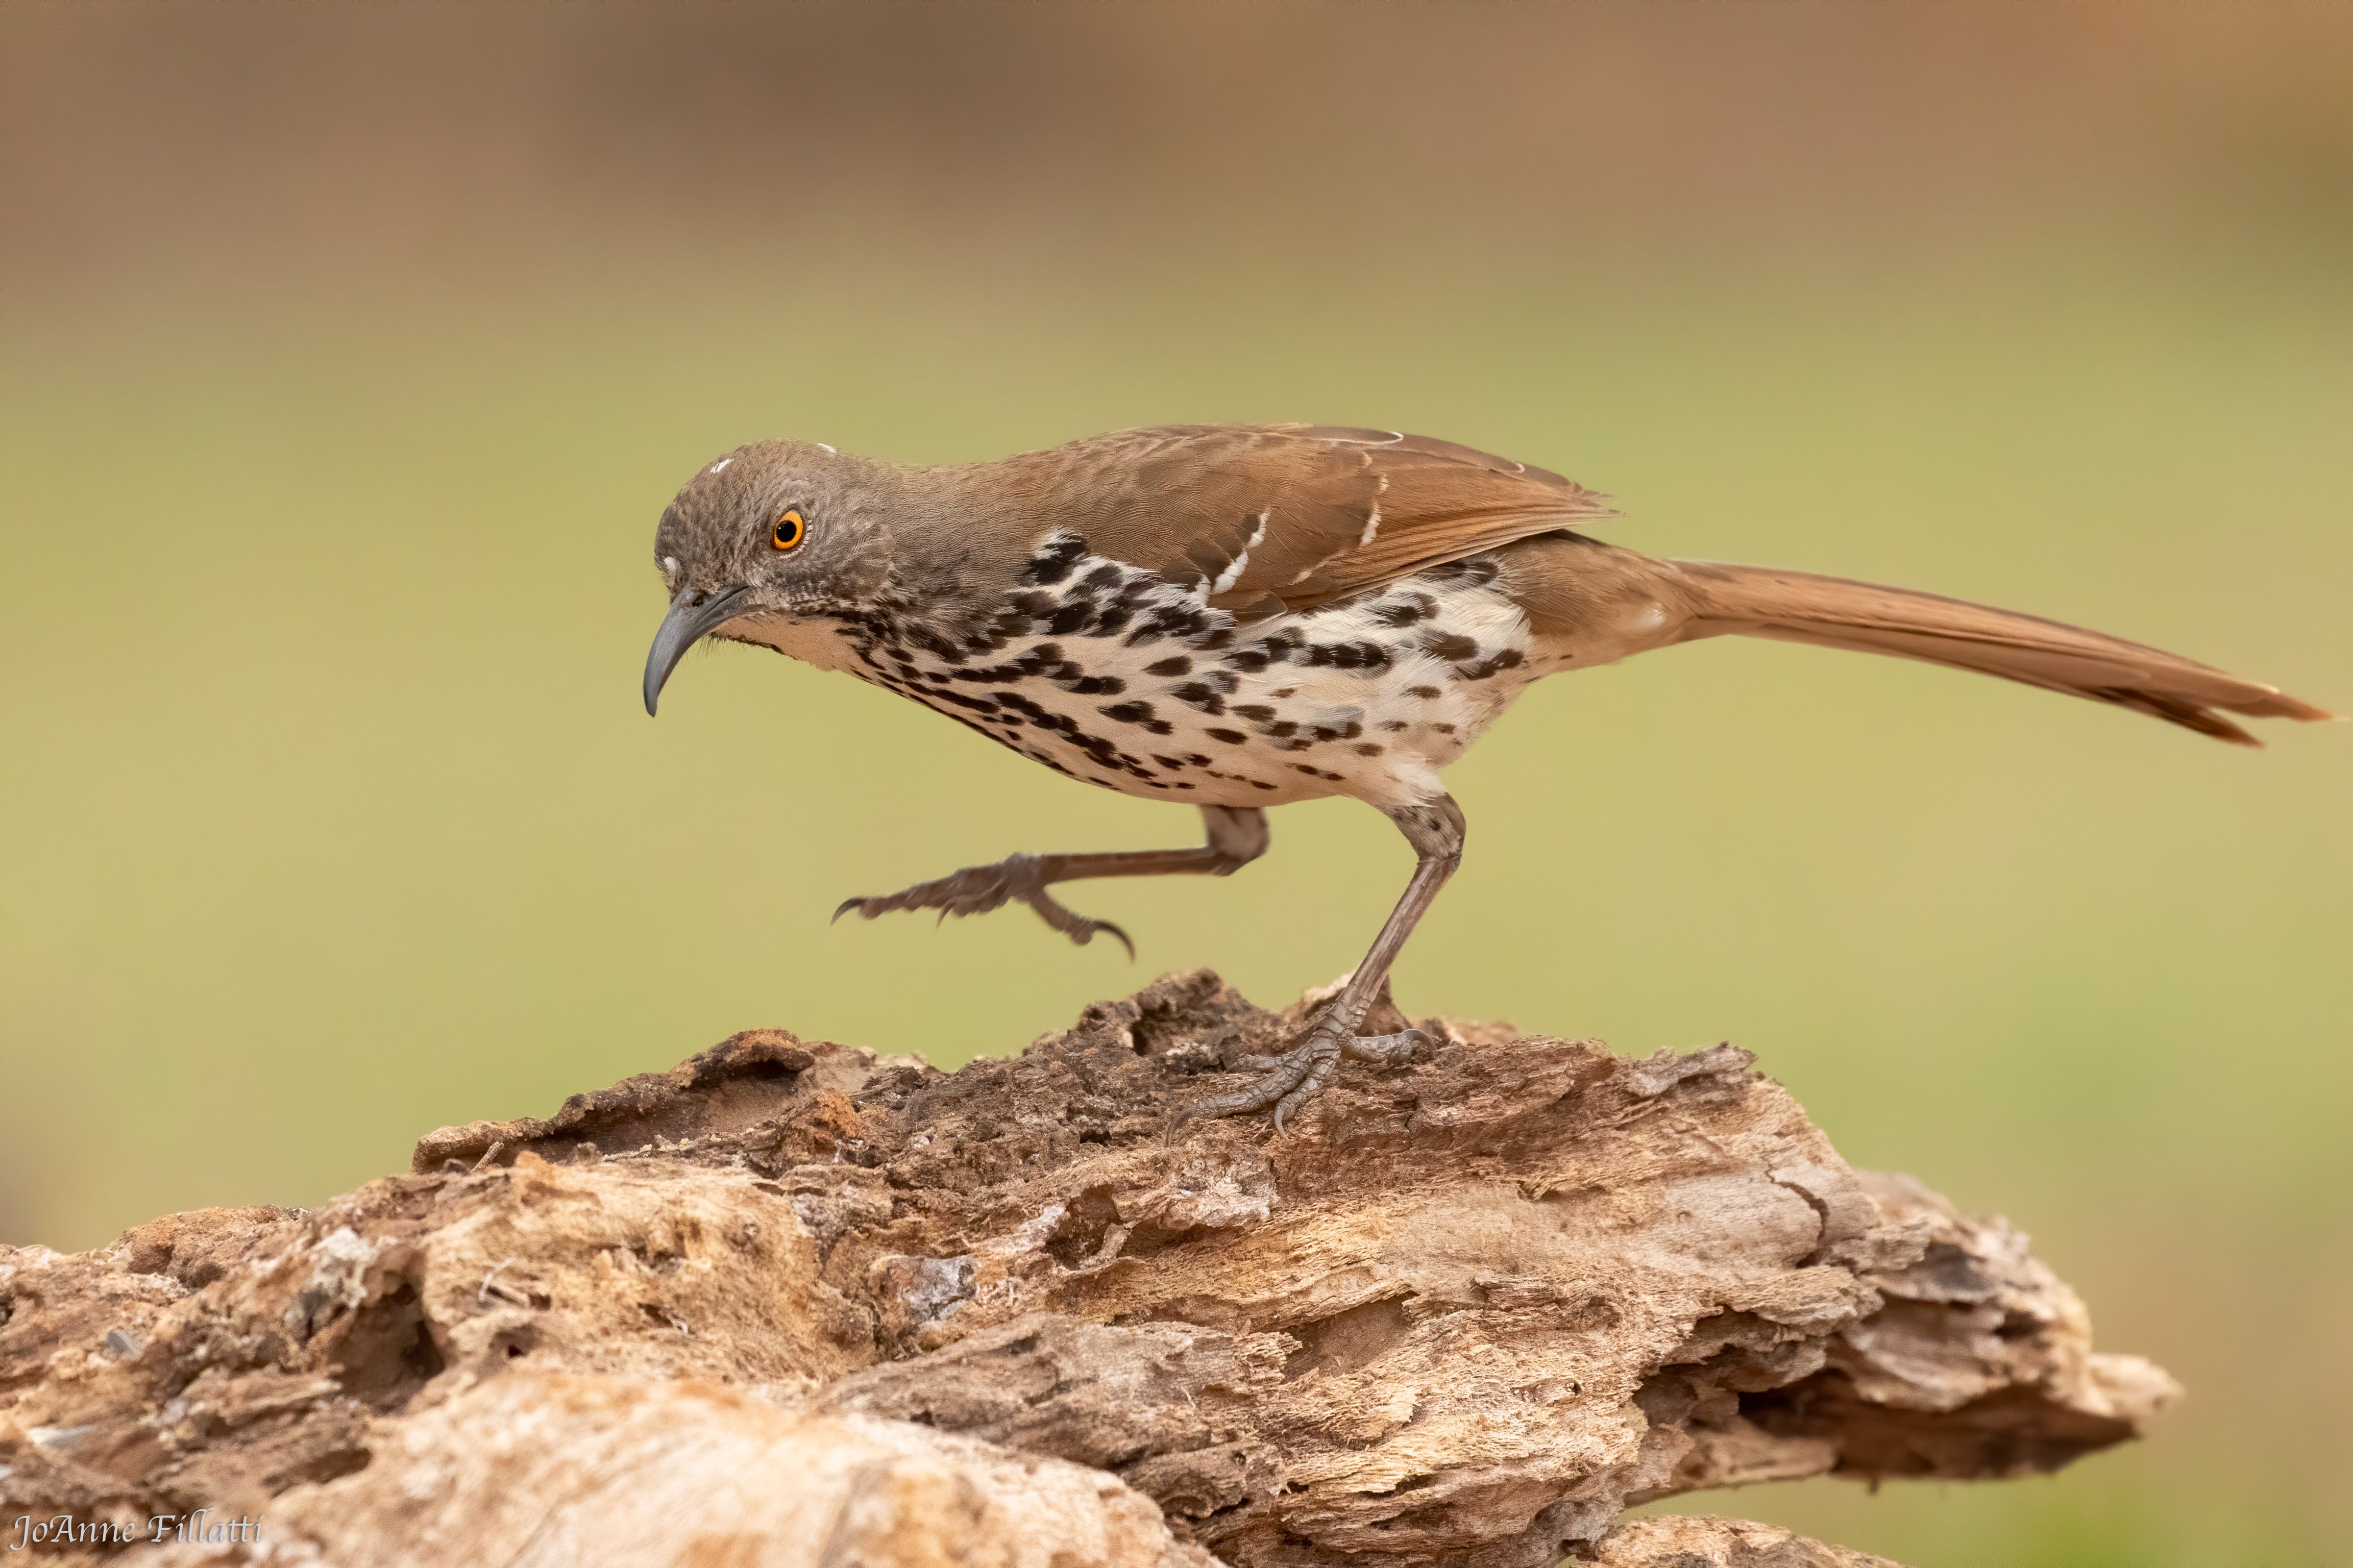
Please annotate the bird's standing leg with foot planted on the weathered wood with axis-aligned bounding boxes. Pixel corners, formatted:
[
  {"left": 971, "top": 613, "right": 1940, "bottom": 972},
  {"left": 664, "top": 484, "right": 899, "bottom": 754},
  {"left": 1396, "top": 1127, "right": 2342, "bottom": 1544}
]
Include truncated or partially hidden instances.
[{"left": 1184, "top": 794, "right": 1463, "bottom": 1133}]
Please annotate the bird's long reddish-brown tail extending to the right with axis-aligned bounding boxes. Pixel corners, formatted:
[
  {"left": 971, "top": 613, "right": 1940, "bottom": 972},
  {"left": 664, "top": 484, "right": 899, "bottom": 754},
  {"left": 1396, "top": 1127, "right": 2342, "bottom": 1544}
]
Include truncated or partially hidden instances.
[{"left": 1671, "top": 562, "right": 2334, "bottom": 745}]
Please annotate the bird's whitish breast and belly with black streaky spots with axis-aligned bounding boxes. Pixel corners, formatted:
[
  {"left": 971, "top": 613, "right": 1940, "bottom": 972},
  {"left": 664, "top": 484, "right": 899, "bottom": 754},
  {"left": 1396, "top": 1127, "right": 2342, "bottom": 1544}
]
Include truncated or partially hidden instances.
[{"left": 795, "top": 531, "right": 1600, "bottom": 806}]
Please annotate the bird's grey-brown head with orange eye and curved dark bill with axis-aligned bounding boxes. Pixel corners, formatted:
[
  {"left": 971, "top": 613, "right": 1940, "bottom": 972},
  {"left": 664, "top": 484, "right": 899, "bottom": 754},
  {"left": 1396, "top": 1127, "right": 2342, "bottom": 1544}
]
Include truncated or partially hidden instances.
[{"left": 645, "top": 442, "right": 896, "bottom": 712}]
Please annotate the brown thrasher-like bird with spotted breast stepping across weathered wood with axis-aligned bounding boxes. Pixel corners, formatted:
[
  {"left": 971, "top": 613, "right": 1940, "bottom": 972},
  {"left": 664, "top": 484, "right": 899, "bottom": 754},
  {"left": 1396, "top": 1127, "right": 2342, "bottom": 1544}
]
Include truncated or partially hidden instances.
[{"left": 645, "top": 426, "right": 2332, "bottom": 1128}]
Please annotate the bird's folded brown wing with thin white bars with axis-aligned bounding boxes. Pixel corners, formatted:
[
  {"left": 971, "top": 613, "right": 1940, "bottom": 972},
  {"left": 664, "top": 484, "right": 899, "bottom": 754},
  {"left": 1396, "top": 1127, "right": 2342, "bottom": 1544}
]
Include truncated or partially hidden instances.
[{"left": 1012, "top": 426, "right": 1614, "bottom": 620}]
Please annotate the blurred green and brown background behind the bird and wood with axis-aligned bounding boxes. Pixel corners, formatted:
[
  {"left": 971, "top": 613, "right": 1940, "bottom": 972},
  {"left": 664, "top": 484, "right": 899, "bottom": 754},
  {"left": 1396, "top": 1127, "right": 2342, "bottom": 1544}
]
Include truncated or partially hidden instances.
[{"left": 0, "top": 0, "right": 2353, "bottom": 1568}]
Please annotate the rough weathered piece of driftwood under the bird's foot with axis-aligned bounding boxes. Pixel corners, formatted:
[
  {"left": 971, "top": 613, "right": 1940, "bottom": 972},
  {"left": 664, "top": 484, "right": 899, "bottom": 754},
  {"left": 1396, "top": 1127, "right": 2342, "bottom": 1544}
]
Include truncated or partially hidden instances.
[{"left": 0, "top": 973, "right": 2174, "bottom": 1568}]
